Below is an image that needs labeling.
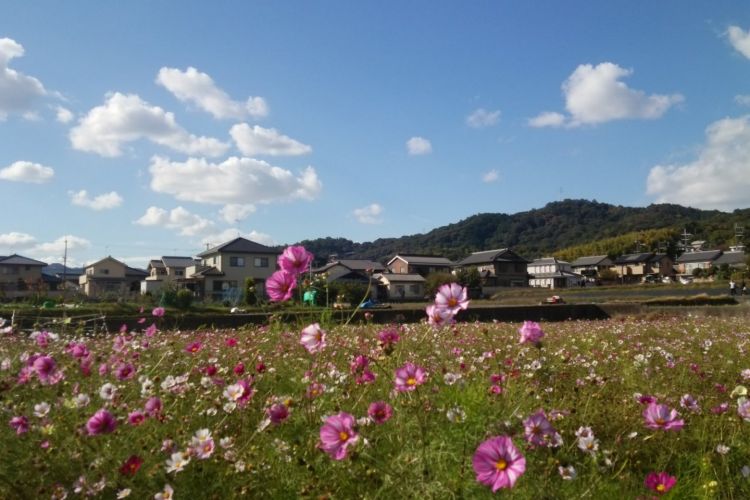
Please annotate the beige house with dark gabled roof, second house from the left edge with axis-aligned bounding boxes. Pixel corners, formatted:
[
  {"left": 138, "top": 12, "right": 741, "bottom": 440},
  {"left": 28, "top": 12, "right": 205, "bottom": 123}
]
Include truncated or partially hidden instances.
[{"left": 78, "top": 255, "right": 148, "bottom": 298}]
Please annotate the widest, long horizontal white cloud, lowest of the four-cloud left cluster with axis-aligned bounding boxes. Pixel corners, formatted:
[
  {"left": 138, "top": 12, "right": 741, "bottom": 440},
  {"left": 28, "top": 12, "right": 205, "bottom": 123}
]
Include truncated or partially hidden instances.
[{"left": 149, "top": 156, "right": 322, "bottom": 205}]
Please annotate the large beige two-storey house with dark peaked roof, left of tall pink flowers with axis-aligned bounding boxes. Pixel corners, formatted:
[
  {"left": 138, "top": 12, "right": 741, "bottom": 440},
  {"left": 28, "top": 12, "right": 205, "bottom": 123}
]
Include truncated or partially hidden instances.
[{"left": 184, "top": 237, "right": 281, "bottom": 300}]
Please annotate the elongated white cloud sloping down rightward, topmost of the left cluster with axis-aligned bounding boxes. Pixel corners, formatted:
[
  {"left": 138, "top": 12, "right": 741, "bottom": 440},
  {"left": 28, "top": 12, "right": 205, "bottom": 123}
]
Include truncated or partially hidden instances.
[{"left": 156, "top": 67, "right": 268, "bottom": 120}]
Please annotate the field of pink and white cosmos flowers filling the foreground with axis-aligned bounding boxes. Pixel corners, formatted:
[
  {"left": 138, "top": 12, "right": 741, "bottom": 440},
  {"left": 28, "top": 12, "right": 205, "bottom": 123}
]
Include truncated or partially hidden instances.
[{"left": 0, "top": 245, "right": 750, "bottom": 499}]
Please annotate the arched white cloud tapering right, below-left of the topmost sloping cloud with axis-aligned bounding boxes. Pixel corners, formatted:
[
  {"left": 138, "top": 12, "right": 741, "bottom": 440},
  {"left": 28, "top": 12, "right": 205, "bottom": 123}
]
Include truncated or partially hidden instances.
[{"left": 70, "top": 92, "right": 229, "bottom": 157}]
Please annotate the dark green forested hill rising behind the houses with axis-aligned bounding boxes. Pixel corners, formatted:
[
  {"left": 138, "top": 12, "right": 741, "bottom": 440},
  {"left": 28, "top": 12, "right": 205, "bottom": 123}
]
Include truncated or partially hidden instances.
[{"left": 299, "top": 200, "right": 750, "bottom": 264}]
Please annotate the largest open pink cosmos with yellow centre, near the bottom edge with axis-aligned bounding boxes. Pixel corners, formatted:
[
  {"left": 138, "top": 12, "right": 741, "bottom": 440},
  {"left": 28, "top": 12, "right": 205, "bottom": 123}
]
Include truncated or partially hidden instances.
[{"left": 472, "top": 436, "right": 526, "bottom": 493}]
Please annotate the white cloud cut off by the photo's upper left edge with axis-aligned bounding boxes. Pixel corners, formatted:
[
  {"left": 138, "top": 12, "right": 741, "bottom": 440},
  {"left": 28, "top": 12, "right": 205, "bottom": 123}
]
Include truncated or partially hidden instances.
[{"left": 0, "top": 38, "right": 47, "bottom": 120}]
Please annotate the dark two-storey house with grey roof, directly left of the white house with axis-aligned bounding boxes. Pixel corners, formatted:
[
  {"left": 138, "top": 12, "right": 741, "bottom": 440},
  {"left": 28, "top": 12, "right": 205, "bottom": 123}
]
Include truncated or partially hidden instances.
[{"left": 456, "top": 248, "right": 529, "bottom": 287}]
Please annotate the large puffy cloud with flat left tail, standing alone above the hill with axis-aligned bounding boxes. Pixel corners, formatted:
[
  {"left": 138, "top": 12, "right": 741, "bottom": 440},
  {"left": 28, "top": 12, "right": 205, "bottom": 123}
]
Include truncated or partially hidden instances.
[{"left": 529, "top": 62, "right": 684, "bottom": 127}]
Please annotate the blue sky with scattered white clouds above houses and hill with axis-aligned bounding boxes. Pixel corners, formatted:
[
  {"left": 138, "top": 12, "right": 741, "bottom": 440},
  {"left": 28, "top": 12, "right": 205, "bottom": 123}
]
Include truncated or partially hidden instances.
[{"left": 0, "top": 0, "right": 750, "bottom": 266}]
